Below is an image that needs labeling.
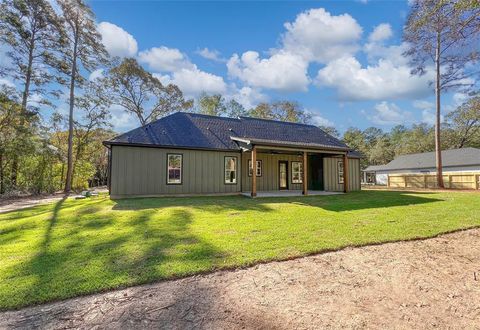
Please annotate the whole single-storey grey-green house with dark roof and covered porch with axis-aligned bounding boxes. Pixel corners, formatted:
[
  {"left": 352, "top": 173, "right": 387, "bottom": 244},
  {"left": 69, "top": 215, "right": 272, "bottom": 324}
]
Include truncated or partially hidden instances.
[{"left": 104, "top": 112, "right": 360, "bottom": 198}]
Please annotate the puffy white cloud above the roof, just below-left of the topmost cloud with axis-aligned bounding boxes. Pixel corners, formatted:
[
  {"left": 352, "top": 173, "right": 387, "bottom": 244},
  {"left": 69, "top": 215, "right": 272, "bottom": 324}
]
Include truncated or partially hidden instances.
[{"left": 227, "top": 51, "right": 309, "bottom": 91}]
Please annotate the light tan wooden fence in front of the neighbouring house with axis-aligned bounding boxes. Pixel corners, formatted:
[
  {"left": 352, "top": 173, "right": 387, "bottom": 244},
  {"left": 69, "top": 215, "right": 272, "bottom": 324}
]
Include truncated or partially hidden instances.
[{"left": 387, "top": 172, "right": 480, "bottom": 190}]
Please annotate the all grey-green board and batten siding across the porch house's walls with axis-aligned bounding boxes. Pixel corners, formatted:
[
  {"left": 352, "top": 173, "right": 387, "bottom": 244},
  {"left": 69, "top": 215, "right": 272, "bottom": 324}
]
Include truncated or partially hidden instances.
[{"left": 110, "top": 145, "right": 360, "bottom": 198}]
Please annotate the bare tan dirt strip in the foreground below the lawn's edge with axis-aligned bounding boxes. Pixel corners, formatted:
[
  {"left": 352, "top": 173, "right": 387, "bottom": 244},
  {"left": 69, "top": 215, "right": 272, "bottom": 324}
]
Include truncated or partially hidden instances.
[{"left": 0, "top": 229, "right": 480, "bottom": 329}]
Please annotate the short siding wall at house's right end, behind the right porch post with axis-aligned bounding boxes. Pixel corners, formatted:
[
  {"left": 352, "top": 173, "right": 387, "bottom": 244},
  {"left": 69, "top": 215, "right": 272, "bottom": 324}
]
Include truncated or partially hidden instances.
[{"left": 323, "top": 157, "right": 361, "bottom": 191}]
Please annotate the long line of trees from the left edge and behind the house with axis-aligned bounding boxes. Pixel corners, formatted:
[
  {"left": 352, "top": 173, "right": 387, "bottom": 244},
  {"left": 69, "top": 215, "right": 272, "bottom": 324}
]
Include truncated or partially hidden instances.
[{"left": 0, "top": 0, "right": 480, "bottom": 195}]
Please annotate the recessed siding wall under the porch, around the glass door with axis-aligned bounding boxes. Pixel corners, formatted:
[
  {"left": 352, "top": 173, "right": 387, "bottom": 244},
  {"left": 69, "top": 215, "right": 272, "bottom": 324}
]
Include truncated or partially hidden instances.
[{"left": 242, "top": 152, "right": 302, "bottom": 191}]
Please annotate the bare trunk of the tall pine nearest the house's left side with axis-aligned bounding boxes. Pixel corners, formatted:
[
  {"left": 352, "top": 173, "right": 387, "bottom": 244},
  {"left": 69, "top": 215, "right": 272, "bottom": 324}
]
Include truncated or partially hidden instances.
[{"left": 65, "top": 30, "right": 79, "bottom": 193}]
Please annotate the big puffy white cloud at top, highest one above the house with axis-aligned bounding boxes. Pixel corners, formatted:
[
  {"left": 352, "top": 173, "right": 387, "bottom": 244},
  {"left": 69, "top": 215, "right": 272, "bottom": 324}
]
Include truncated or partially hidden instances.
[{"left": 282, "top": 8, "right": 362, "bottom": 63}]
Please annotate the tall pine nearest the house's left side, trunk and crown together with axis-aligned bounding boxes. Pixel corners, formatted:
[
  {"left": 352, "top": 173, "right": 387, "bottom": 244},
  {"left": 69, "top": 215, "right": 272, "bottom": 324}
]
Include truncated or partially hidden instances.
[{"left": 57, "top": 0, "right": 108, "bottom": 192}]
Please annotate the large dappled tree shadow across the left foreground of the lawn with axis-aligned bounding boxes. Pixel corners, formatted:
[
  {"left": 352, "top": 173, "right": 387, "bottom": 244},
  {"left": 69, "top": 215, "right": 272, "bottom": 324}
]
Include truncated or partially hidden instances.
[{"left": 0, "top": 196, "right": 225, "bottom": 310}]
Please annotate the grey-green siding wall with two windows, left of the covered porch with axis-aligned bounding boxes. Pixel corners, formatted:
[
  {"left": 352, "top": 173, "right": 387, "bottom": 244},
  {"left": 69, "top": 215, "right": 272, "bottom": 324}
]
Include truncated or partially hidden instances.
[{"left": 111, "top": 146, "right": 242, "bottom": 197}]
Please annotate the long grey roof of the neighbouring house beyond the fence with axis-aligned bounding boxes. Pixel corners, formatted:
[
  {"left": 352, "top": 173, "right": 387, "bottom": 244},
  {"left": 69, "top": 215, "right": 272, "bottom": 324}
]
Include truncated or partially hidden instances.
[{"left": 365, "top": 148, "right": 480, "bottom": 172}]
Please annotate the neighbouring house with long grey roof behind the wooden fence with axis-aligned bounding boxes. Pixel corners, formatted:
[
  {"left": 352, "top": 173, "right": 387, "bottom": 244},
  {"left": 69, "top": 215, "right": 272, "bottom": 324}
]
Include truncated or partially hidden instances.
[{"left": 363, "top": 148, "right": 480, "bottom": 185}]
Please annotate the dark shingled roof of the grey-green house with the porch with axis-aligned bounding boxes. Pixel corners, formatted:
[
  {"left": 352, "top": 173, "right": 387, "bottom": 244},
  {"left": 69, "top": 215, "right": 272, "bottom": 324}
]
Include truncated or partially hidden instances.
[{"left": 104, "top": 112, "right": 348, "bottom": 151}]
